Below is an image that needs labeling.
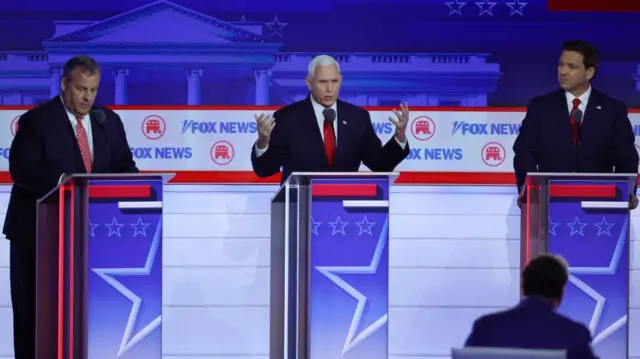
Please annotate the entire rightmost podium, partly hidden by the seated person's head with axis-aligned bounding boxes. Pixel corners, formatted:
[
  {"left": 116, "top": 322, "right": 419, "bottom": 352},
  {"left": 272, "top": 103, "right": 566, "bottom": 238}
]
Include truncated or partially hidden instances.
[{"left": 521, "top": 173, "right": 638, "bottom": 359}]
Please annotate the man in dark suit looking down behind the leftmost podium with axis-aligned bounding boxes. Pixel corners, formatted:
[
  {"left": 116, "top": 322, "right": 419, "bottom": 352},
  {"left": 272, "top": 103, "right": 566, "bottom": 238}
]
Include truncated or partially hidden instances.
[{"left": 3, "top": 56, "right": 138, "bottom": 359}]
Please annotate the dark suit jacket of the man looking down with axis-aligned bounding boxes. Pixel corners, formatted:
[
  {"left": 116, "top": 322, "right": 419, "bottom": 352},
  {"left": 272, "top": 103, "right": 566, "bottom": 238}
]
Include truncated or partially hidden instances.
[{"left": 3, "top": 96, "right": 138, "bottom": 240}]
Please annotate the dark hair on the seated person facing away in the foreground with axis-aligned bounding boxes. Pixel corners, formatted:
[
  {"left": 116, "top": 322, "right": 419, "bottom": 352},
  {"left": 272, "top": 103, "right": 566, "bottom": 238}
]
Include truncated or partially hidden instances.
[{"left": 522, "top": 254, "right": 569, "bottom": 300}]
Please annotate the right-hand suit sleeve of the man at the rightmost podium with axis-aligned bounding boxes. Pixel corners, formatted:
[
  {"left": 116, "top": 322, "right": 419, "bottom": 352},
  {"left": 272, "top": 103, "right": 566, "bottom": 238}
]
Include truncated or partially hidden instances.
[{"left": 613, "top": 103, "right": 640, "bottom": 184}]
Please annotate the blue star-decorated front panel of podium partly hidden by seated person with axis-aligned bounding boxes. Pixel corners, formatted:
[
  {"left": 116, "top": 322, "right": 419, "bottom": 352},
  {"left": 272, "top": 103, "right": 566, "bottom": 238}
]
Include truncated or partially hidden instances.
[{"left": 549, "top": 180, "right": 630, "bottom": 359}]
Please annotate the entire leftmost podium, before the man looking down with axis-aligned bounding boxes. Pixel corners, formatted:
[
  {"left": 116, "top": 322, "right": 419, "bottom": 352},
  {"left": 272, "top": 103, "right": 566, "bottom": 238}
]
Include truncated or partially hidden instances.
[{"left": 36, "top": 174, "right": 173, "bottom": 359}]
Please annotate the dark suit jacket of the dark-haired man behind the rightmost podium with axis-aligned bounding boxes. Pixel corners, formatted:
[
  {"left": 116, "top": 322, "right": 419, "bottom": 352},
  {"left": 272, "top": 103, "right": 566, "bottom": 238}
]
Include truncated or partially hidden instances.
[{"left": 513, "top": 88, "right": 638, "bottom": 193}]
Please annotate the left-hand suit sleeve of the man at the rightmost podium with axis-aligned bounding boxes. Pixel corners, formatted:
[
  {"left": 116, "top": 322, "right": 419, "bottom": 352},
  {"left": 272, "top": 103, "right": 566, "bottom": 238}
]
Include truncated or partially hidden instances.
[{"left": 513, "top": 101, "right": 539, "bottom": 192}]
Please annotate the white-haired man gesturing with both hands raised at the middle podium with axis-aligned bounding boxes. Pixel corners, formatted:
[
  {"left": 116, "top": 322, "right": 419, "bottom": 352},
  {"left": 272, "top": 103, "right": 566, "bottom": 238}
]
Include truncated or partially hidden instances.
[{"left": 251, "top": 55, "right": 409, "bottom": 181}]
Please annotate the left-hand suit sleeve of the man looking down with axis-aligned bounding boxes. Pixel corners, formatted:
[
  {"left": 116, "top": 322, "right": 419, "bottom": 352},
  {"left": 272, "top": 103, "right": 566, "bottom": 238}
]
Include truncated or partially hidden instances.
[{"left": 9, "top": 111, "right": 62, "bottom": 197}]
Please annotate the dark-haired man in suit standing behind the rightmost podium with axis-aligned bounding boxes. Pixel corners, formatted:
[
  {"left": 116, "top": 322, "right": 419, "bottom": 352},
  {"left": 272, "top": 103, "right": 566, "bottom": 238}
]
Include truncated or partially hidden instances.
[{"left": 513, "top": 40, "right": 638, "bottom": 209}]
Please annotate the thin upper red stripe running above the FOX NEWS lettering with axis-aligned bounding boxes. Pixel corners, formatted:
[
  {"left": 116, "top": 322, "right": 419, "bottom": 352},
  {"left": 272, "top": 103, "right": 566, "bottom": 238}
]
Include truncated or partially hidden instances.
[{"left": 0, "top": 105, "right": 640, "bottom": 113}]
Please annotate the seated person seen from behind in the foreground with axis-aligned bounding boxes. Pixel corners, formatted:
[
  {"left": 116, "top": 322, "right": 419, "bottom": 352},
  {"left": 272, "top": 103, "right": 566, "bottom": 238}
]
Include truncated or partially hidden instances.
[{"left": 465, "top": 254, "right": 596, "bottom": 359}]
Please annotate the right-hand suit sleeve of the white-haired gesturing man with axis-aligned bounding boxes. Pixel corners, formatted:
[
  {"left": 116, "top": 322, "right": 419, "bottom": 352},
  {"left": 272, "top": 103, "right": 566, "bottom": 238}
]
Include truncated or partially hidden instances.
[{"left": 362, "top": 111, "right": 410, "bottom": 172}]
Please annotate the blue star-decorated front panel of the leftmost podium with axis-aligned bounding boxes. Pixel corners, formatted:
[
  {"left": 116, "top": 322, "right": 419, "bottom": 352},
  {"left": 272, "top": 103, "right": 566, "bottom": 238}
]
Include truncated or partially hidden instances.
[{"left": 87, "top": 180, "right": 162, "bottom": 359}]
